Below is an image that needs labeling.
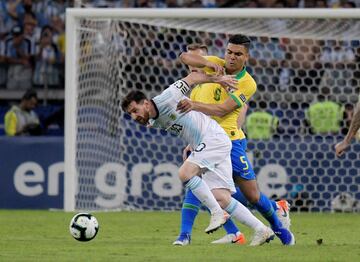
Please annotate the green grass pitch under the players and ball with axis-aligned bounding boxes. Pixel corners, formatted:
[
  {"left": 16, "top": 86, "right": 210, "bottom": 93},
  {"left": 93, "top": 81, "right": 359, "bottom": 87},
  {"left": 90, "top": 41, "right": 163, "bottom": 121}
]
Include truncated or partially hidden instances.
[{"left": 0, "top": 210, "right": 360, "bottom": 262}]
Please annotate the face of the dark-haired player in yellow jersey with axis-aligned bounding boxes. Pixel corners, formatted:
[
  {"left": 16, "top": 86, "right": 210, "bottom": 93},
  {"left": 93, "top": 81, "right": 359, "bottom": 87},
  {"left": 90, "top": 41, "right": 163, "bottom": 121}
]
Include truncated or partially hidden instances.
[{"left": 225, "top": 44, "right": 249, "bottom": 74}]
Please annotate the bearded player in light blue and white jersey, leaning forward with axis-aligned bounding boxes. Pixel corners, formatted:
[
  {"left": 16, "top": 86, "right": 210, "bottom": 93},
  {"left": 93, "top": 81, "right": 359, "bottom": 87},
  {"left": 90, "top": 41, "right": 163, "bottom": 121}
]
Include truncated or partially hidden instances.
[{"left": 121, "top": 72, "right": 274, "bottom": 245}]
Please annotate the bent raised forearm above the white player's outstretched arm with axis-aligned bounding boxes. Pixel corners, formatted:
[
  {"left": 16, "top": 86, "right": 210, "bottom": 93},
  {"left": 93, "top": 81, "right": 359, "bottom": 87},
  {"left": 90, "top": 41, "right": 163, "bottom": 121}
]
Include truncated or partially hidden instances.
[{"left": 180, "top": 52, "right": 225, "bottom": 75}]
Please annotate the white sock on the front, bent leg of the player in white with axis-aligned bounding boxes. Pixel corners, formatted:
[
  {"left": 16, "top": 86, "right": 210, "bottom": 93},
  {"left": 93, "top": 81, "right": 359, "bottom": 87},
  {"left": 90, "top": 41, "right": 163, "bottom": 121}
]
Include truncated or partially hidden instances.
[{"left": 186, "top": 176, "right": 222, "bottom": 214}]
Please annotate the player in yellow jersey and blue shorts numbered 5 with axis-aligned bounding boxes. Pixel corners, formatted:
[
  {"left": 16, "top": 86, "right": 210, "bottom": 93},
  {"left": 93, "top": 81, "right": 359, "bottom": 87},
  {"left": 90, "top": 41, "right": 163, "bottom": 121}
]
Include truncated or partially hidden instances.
[{"left": 174, "top": 35, "right": 295, "bottom": 245}]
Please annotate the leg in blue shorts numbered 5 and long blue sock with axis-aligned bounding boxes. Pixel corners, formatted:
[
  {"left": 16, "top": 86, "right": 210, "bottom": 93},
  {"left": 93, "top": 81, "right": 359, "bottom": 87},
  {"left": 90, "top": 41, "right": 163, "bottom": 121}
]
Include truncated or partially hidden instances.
[{"left": 232, "top": 139, "right": 295, "bottom": 245}]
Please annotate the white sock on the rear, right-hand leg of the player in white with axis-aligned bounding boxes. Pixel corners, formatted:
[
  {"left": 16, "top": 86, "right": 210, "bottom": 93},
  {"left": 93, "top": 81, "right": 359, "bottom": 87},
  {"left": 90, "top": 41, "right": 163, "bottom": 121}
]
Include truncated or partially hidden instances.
[{"left": 225, "top": 198, "right": 266, "bottom": 231}]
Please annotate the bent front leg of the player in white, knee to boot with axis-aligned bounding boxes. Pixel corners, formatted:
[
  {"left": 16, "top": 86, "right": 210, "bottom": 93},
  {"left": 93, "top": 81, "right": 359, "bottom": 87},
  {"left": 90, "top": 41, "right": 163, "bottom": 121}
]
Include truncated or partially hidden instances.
[{"left": 179, "top": 160, "right": 228, "bottom": 233}]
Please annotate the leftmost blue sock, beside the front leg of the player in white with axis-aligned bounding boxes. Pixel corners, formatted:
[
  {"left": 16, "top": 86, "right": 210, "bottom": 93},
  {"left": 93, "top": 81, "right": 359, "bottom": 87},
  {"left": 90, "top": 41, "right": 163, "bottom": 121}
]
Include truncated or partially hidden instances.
[{"left": 180, "top": 189, "right": 201, "bottom": 235}]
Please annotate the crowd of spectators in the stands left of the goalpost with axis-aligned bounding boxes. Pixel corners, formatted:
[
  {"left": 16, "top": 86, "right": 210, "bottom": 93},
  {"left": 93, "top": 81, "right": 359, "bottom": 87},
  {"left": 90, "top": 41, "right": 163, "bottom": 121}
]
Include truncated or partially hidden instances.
[{"left": 0, "top": 0, "right": 66, "bottom": 90}]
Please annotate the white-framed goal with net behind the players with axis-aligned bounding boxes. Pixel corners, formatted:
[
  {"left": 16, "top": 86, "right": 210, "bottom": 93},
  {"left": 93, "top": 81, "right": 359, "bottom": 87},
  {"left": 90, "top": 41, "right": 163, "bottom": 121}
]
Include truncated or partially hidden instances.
[{"left": 64, "top": 9, "right": 360, "bottom": 211}]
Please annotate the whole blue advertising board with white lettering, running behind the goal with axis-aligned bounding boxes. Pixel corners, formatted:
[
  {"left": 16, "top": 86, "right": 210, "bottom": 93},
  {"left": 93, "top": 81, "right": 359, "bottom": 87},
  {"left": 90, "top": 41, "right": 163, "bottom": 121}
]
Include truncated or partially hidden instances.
[{"left": 0, "top": 137, "right": 360, "bottom": 211}]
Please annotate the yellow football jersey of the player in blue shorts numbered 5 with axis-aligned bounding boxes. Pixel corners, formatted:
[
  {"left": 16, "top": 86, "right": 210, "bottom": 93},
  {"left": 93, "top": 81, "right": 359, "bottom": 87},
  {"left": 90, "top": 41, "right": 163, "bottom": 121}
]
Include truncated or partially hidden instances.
[{"left": 190, "top": 56, "right": 256, "bottom": 140}]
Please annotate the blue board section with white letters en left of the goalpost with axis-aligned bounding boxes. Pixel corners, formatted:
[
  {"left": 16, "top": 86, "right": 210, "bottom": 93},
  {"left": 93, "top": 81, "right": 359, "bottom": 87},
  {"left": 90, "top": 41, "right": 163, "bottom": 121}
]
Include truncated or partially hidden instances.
[{"left": 0, "top": 137, "right": 64, "bottom": 209}]
